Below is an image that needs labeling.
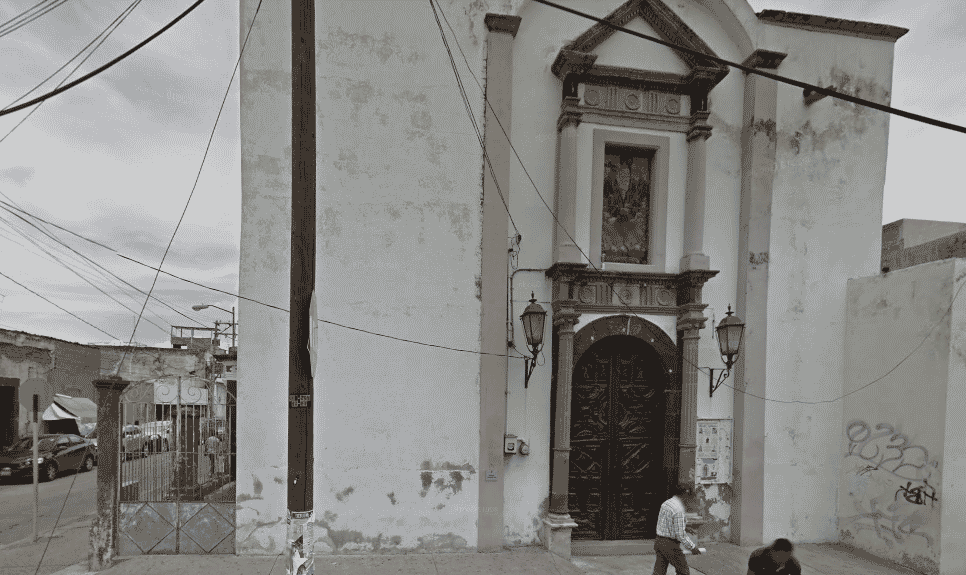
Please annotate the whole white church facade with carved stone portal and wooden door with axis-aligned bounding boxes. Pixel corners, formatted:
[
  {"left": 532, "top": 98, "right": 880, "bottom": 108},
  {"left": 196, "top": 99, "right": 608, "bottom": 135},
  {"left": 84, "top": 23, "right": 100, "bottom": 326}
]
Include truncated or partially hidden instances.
[{"left": 237, "top": 0, "right": 906, "bottom": 556}]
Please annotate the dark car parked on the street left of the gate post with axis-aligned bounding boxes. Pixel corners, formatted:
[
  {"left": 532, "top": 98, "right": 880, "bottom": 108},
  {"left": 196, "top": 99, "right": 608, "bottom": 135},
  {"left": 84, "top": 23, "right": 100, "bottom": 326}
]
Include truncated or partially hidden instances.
[{"left": 0, "top": 433, "right": 96, "bottom": 481}]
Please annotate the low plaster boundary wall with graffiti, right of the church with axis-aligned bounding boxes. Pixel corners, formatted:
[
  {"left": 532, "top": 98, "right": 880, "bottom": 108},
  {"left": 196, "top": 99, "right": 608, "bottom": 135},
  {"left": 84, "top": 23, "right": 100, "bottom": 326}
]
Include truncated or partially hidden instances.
[{"left": 837, "top": 260, "right": 966, "bottom": 574}]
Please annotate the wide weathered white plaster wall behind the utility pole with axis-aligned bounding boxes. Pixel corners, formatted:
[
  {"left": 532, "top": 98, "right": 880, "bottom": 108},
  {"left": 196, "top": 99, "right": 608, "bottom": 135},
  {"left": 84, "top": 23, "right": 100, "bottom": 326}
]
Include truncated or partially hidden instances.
[{"left": 238, "top": 1, "right": 485, "bottom": 553}]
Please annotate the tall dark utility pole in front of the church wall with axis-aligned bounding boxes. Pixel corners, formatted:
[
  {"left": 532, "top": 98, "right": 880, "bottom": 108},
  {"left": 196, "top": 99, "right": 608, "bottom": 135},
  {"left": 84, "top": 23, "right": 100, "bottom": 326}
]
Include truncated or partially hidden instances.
[{"left": 286, "top": 0, "right": 316, "bottom": 575}]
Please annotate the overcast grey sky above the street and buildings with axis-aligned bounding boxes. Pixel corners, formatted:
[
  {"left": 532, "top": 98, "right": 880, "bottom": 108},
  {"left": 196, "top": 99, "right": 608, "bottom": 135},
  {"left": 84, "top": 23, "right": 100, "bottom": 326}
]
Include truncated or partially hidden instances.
[{"left": 0, "top": 0, "right": 966, "bottom": 345}]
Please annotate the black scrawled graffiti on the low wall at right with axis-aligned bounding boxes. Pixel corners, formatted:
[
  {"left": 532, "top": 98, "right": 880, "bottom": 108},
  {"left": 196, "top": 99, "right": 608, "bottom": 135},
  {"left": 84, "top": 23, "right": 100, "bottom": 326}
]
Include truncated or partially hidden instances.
[{"left": 841, "top": 420, "right": 939, "bottom": 549}]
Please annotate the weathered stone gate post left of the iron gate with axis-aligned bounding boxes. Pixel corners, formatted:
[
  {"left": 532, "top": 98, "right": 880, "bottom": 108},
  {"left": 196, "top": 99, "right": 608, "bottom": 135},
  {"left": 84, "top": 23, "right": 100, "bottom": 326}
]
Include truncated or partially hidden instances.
[{"left": 88, "top": 377, "right": 131, "bottom": 571}]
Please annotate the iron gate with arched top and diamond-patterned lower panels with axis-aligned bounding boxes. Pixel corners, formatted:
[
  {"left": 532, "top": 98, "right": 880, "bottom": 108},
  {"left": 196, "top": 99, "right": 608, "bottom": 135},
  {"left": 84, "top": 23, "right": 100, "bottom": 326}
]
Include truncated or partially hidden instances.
[{"left": 117, "top": 377, "right": 236, "bottom": 556}]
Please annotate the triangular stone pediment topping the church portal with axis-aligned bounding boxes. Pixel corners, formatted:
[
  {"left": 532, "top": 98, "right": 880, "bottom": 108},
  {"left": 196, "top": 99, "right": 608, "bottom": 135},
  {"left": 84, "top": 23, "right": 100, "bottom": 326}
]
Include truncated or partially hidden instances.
[{"left": 552, "top": 0, "right": 728, "bottom": 90}]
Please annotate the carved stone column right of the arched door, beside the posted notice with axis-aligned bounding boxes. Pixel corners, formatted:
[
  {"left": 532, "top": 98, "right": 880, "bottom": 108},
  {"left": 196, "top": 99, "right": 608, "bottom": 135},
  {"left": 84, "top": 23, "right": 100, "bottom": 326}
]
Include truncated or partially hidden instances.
[{"left": 678, "top": 270, "right": 718, "bottom": 485}]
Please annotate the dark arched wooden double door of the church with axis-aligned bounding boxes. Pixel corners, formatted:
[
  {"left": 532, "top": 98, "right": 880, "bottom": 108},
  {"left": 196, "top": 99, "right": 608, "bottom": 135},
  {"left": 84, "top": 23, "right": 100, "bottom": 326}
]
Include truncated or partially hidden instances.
[{"left": 568, "top": 335, "right": 667, "bottom": 540}]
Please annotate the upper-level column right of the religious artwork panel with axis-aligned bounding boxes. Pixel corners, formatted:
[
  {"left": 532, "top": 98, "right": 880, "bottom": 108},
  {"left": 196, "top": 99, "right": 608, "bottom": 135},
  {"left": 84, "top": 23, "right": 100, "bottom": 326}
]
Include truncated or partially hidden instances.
[{"left": 681, "top": 94, "right": 711, "bottom": 271}]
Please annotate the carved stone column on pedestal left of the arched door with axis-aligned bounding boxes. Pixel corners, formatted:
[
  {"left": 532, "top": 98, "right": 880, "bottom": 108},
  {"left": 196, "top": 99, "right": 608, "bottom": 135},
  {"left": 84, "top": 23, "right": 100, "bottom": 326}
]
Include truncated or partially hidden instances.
[{"left": 543, "top": 264, "right": 586, "bottom": 559}]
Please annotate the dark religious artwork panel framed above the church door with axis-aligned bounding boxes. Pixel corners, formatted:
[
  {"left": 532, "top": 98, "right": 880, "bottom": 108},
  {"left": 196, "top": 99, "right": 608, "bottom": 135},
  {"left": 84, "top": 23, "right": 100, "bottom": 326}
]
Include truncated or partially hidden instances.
[{"left": 601, "top": 145, "right": 654, "bottom": 264}]
